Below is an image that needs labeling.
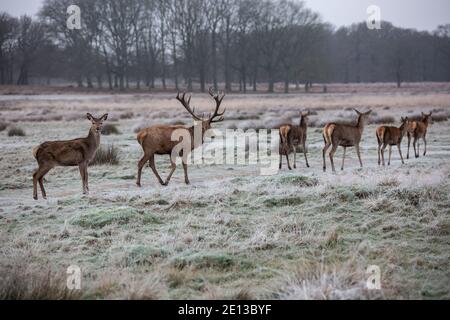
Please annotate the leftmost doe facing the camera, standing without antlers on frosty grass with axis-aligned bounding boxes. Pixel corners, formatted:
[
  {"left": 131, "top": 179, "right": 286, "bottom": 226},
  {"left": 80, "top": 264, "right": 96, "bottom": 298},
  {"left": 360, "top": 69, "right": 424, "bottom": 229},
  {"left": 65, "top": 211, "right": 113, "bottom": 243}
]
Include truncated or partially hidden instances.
[{"left": 33, "top": 113, "right": 108, "bottom": 200}]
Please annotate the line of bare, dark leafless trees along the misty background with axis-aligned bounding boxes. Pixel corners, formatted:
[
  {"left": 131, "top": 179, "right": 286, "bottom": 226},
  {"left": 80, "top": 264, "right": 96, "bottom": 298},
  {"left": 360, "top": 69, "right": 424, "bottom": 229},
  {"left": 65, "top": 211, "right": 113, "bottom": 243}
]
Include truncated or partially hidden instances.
[{"left": 0, "top": 0, "right": 450, "bottom": 92}]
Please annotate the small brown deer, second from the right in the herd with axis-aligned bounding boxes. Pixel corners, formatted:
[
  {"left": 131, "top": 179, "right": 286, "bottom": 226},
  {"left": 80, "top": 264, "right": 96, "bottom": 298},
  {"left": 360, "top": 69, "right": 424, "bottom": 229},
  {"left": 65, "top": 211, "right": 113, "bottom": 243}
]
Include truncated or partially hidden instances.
[{"left": 376, "top": 117, "right": 409, "bottom": 166}]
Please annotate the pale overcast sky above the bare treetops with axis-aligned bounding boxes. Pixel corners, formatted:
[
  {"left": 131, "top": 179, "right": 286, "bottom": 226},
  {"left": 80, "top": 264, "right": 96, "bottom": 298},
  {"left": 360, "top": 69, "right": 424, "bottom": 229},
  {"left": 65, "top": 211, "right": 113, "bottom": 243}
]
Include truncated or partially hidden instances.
[{"left": 0, "top": 0, "right": 450, "bottom": 30}]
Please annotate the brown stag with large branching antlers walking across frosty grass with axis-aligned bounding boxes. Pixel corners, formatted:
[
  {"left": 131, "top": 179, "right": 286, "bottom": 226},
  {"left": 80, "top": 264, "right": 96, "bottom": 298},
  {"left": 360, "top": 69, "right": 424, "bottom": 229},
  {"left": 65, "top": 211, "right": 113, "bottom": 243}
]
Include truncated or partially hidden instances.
[{"left": 136, "top": 88, "right": 225, "bottom": 187}]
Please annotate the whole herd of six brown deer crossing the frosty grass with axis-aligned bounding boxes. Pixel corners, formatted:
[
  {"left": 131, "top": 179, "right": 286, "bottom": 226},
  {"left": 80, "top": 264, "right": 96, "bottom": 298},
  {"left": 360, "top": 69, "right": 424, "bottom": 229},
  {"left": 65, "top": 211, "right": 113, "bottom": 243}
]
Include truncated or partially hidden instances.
[{"left": 33, "top": 89, "right": 432, "bottom": 200}]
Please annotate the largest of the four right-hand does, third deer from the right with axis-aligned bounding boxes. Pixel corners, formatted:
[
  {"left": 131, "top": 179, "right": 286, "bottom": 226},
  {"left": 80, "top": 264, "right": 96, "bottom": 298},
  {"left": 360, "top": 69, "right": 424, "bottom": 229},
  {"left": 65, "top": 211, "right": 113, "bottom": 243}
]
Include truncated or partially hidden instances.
[{"left": 323, "top": 109, "right": 372, "bottom": 172}]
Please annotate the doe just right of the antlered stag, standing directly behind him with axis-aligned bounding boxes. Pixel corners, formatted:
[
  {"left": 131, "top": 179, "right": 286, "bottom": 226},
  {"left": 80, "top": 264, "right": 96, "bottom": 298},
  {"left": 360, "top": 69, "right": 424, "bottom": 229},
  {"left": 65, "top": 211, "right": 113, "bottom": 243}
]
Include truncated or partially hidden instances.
[{"left": 279, "top": 111, "right": 310, "bottom": 170}]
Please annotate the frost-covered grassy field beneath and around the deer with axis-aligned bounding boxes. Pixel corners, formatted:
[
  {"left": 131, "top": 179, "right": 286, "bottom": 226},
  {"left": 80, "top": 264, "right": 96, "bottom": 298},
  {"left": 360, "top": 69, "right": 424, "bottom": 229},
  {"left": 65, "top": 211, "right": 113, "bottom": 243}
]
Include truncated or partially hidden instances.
[{"left": 0, "top": 86, "right": 450, "bottom": 299}]
